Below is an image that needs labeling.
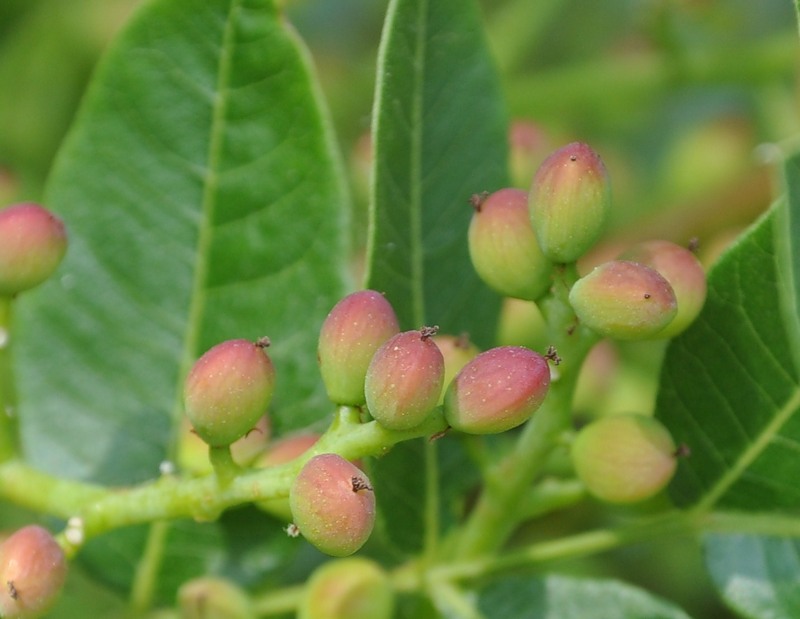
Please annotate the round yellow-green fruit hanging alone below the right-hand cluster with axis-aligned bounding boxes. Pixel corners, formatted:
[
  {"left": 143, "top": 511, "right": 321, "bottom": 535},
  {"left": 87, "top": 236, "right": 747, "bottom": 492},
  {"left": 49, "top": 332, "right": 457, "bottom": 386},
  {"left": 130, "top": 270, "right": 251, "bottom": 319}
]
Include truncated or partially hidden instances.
[{"left": 572, "top": 415, "right": 677, "bottom": 503}]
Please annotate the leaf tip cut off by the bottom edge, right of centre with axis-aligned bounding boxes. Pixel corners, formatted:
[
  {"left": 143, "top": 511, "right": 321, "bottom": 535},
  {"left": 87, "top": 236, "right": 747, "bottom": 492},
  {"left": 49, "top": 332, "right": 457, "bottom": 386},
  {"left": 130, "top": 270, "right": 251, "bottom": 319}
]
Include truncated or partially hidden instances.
[{"left": 478, "top": 576, "right": 688, "bottom": 619}]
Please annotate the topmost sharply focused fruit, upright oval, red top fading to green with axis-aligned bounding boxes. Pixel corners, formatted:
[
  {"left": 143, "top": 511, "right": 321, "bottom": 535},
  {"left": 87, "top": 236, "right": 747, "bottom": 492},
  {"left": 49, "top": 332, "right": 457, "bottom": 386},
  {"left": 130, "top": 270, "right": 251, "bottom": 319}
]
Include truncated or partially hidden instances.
[{"left": 528, "top": 142, "right": 611, "bottom": 263}]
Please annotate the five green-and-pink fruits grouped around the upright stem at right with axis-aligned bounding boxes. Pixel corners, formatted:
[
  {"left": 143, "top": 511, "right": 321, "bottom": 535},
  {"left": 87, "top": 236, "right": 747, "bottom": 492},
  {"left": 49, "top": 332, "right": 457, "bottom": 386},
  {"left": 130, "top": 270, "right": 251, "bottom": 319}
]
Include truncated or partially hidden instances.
[{"left": 469, "top": 142, "right": 706, "bottom": 503}]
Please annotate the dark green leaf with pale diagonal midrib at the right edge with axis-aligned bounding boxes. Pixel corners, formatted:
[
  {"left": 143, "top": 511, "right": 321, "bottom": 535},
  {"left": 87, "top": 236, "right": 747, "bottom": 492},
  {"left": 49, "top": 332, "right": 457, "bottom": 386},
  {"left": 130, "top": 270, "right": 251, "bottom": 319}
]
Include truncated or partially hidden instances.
[{"left": 657, "top": 197, "right": 800, "bottom": 510}]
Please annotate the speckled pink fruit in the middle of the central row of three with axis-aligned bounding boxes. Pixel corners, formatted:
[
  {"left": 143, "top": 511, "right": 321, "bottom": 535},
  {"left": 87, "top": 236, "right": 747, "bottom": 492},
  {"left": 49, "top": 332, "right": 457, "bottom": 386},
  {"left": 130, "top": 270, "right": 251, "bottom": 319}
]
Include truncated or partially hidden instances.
[{"left": 364, "top": 327, "right": 444, "bottom": 430}]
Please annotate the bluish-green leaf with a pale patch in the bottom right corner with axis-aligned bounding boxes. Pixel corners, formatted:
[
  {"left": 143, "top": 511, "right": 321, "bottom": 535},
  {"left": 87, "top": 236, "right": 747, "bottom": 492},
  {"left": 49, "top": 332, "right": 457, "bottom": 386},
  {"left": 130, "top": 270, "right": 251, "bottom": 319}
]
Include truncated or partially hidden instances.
[{"left": 704, "top": 535, "right": 800, "bottom": 619}]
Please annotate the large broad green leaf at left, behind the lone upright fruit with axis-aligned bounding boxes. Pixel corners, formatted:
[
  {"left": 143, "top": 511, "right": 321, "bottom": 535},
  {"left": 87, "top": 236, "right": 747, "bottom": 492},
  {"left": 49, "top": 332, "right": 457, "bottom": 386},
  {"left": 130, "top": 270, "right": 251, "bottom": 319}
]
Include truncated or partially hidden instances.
[{"left": 16, "top": 0, "right": 348, "bottom": 600}]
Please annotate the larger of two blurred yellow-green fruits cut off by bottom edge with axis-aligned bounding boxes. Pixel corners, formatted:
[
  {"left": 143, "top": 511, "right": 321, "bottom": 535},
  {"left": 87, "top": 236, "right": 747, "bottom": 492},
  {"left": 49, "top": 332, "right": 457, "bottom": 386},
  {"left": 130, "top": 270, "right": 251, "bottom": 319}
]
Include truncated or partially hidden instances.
[{"left": 297, "top": 557, "right": 394, "bottom": 619}]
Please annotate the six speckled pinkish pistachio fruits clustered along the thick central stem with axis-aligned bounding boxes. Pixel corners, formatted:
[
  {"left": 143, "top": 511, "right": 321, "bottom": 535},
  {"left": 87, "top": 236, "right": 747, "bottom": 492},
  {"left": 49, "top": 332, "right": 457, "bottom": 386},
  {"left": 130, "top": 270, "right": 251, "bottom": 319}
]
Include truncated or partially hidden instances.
[{"left": 184, "top": 290, "right": 550, "bottom": 557}]
